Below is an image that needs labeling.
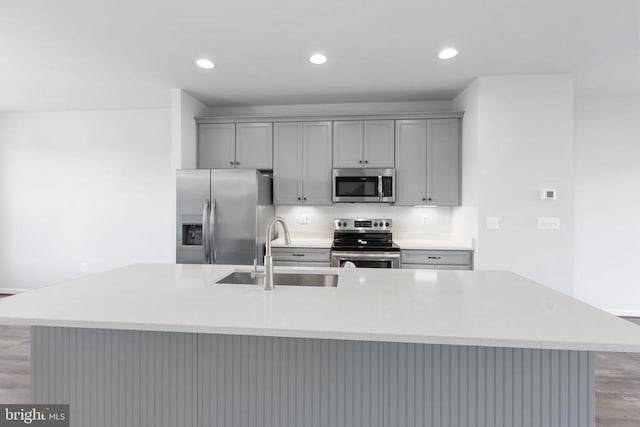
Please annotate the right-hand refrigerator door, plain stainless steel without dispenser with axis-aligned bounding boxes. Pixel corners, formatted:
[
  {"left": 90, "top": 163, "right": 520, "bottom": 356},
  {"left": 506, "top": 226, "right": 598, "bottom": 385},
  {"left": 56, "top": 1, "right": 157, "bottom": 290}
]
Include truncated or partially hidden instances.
[{"left": 211, "top": 169, "right": 258, "bottom": 265}]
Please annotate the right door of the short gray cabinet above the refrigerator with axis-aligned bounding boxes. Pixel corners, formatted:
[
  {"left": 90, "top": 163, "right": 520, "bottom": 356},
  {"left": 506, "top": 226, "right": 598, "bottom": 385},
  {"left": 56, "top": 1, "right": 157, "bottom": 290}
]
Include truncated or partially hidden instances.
[{"left": 236, "top": 123, "right": 273, "bottom": 169}]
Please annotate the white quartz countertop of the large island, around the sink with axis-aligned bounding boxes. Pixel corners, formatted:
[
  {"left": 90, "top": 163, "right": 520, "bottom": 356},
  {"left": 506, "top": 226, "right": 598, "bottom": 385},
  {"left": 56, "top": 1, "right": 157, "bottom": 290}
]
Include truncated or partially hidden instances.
[{"left": 0, "top": 264, "right": 640, "bottom": 352}]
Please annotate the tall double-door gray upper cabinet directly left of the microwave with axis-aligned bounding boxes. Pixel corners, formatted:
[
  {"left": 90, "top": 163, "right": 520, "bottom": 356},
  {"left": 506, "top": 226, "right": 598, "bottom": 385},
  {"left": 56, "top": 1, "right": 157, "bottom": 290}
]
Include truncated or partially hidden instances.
[{"left": 273, "top": 122, "right": 333, "bottom": 205}]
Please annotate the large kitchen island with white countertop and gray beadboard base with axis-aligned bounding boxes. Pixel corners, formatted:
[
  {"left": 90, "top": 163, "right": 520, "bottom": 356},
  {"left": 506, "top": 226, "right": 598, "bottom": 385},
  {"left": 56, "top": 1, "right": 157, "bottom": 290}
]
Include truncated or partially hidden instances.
[{"left": 0, "top": 265, "right": 640, "bottom": 426}]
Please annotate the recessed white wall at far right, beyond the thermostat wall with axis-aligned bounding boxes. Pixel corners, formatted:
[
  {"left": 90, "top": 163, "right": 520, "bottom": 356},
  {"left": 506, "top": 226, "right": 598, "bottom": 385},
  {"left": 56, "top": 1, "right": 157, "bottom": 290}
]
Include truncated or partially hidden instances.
[{"left": 574, "top": 96, "right": 640, "bottom": 316}]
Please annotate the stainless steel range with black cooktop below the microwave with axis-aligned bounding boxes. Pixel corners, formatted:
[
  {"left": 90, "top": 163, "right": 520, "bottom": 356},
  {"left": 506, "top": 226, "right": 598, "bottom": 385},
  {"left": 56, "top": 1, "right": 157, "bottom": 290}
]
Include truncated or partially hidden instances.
[{"left": 331, "top": 218, "right": 400, "bottom": 268}]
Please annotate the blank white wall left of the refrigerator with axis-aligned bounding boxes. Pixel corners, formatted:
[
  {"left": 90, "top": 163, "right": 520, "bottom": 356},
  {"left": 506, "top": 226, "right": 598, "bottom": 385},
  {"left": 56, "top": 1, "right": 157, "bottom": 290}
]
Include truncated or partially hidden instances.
[{"left": 0, "top": 110, "right": 175, "bottom": 290}]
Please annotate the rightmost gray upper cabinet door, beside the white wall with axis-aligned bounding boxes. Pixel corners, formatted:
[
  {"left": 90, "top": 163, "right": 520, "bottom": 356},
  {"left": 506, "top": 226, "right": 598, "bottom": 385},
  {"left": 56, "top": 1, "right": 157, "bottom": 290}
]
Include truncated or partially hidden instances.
[{"left": 427, "top": 119, "right": 460, "bottom": 206}]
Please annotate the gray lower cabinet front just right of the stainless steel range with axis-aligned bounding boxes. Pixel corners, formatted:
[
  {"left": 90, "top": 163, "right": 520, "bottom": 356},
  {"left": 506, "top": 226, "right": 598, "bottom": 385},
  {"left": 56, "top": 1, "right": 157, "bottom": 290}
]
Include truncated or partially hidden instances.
[{"left": 400, "top": 249, "right": 473, "bottom": 270}]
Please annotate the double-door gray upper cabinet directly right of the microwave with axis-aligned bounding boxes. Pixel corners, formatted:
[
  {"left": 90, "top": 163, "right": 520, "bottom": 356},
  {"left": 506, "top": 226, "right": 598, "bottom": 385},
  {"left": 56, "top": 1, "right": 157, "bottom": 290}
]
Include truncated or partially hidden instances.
[{"left": 395, "top": 119, "right": 460, "bottom": 206}]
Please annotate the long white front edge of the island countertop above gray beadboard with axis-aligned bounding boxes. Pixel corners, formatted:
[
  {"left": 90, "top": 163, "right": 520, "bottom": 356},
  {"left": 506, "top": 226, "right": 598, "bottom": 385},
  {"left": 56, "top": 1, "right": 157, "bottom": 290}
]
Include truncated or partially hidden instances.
[{"left": 3, "top": 318, "right": 640, "bottom": 353}]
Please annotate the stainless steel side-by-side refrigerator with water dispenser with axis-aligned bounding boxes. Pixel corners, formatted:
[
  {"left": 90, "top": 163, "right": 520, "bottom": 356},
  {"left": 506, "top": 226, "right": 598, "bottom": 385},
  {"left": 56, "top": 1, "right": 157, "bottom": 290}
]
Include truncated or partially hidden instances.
[{"left": 176, "top": 169, "right": 274, "bottom": 265}]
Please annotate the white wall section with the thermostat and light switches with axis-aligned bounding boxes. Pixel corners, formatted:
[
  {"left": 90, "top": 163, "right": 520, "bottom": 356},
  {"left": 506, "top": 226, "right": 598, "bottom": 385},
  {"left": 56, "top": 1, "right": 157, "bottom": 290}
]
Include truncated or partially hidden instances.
[{"left": 454, "top": 75, "right": 573, "bottom": 294}]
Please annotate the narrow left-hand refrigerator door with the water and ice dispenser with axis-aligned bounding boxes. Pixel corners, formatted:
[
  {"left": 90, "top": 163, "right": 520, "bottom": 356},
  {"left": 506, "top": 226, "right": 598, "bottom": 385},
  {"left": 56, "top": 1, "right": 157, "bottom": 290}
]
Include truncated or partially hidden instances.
[{"left": 176, "top": 169, "right": 211, "bottom": 264}]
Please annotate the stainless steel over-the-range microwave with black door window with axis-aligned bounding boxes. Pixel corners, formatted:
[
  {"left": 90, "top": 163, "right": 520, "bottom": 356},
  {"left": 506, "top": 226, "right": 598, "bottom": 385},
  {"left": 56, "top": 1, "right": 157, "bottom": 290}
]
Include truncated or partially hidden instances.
[{"left": 333, "top": 169, "right": 396, "bottom": 203}]
